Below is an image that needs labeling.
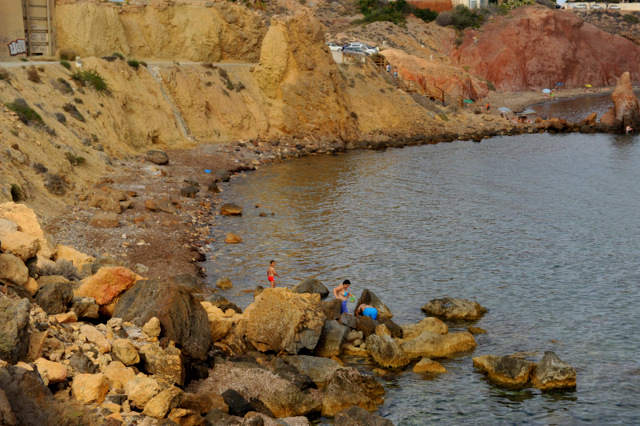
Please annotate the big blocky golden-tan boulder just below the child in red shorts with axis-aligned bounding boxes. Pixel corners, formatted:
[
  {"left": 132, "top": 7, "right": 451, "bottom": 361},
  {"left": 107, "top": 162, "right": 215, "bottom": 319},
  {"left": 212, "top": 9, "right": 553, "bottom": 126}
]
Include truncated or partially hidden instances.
[{"left": 244, "top": 288, "right": 325, "bottom": 354}]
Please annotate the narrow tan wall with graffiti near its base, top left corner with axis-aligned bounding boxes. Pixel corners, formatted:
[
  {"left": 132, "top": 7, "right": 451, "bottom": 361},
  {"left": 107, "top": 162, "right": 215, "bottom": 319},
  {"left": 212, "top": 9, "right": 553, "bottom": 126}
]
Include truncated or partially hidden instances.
[{"left": 0, "top": 0, "right": 27, "bottom": 60}]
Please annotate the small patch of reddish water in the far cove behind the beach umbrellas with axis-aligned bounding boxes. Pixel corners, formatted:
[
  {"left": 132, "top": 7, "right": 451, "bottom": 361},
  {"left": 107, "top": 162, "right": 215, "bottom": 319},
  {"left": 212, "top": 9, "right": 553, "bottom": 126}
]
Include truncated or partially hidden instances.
[{"left": 530, "top": 90, "right": 640, "bottom": 123}]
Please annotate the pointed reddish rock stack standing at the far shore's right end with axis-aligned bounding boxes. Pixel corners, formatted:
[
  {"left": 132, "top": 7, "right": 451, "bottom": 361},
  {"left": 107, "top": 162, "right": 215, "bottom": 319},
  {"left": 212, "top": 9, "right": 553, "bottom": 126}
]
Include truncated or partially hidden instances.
[{"left": 600, "top": 72, "right": 640, "bottom": 133}]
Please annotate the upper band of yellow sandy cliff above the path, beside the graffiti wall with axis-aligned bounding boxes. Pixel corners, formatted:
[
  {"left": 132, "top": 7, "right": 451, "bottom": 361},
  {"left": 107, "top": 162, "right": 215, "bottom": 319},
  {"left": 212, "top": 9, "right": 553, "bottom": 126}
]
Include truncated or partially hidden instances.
[{"left": 56, "top": 1, "right": 266, "bottom": 62}]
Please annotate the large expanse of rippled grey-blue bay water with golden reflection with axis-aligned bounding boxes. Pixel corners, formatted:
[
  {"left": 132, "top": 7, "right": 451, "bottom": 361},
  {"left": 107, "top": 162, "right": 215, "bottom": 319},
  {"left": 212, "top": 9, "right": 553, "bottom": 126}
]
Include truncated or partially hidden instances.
[{"left": 206, "top": 134, "right": 640, "bottom": 425}]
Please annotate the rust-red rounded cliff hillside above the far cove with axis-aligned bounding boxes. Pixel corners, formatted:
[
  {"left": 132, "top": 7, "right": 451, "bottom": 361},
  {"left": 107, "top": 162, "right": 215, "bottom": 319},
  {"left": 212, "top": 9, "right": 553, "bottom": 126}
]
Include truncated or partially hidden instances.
[{"left": 452, "top": 7, "right": 640, "bottom": 91}]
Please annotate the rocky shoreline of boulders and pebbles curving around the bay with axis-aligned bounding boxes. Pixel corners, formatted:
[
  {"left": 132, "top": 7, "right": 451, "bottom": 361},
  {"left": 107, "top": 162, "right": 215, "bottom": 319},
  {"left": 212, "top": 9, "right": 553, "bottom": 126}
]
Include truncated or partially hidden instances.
[{"left": 0, "top": 76, "right": 640, "bottom": 425}]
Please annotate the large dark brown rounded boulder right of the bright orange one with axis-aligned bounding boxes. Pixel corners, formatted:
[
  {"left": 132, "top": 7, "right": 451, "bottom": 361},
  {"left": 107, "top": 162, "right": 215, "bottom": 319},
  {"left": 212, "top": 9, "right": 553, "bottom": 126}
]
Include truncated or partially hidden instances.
[{"left": 113, "top": 278, "right": 211, "bottom": 359}]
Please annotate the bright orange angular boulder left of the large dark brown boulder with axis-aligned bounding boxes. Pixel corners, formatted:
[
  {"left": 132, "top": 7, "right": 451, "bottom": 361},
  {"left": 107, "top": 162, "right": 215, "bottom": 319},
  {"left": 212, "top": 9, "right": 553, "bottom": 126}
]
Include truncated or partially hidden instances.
[{"left": 74, "top": 267, "right": 143, "bottom": 316}]
